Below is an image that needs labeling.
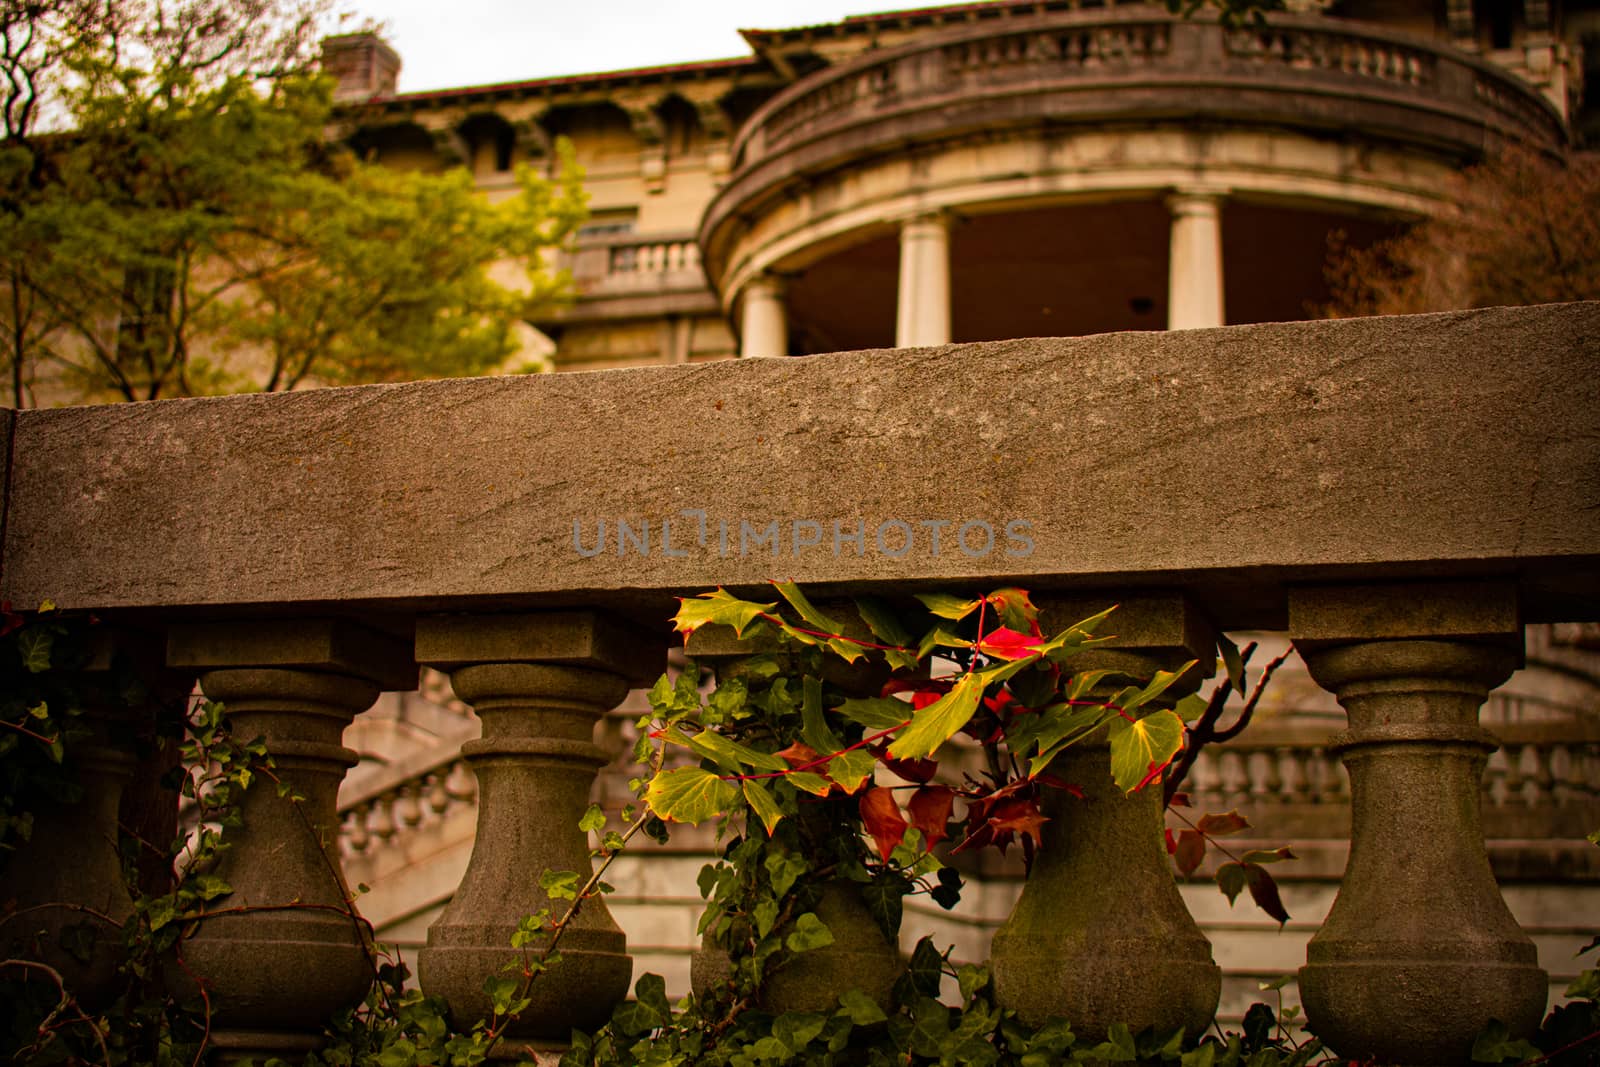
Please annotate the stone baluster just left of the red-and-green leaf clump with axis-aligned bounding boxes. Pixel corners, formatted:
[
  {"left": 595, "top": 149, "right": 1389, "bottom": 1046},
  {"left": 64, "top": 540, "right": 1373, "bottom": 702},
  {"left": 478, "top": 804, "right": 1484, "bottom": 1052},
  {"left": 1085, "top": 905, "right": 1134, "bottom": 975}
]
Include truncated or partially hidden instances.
[{"left": 416, "top": 611, "right": 666, "bottom": 1045}]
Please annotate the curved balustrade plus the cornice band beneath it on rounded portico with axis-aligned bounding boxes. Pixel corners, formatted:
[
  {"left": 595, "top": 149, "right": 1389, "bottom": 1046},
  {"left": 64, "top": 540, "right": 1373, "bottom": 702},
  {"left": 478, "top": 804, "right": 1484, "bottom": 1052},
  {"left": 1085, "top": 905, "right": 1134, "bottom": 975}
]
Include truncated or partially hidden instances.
[{"left": 701, "top": 5, "right": 1566, "bottom": 277}]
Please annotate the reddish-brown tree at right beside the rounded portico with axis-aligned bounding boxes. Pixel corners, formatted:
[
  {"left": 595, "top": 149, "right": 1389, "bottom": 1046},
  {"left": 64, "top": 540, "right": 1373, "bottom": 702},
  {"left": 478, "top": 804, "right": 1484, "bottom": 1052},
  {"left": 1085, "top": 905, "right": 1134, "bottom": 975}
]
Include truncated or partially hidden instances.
[{"left": 1325, "top": 146, "right": 1600, "bottom": 317}]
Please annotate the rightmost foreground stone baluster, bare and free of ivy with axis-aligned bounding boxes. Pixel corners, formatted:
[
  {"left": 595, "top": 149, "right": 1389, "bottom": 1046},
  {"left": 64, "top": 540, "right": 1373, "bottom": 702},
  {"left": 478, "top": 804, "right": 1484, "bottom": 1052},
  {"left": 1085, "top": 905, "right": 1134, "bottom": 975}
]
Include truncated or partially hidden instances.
[{"left": 1290, "top": 582, "right": 1549, "bottom": 1064}]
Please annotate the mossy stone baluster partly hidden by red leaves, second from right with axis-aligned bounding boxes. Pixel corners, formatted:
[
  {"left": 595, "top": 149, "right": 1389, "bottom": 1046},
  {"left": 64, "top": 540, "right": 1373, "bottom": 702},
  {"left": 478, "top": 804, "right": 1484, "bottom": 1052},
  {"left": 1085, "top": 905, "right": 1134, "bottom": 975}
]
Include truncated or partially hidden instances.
[{"left": 990, "top": 595, "right": 1222, "bottom": 1041}]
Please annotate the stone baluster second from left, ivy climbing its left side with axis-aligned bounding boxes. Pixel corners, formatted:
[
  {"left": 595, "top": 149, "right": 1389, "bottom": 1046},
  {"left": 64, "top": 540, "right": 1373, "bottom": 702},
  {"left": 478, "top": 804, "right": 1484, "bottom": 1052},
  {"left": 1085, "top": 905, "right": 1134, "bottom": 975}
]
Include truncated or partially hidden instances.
[{"left": 166, "top": 619, "right": 416, "bottom": 1057}]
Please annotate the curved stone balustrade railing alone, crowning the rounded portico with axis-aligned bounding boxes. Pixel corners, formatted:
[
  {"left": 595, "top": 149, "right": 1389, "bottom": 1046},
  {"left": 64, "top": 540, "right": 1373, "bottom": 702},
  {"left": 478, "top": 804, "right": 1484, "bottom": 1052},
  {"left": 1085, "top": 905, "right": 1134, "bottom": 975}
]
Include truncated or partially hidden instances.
[{"left": 733, "top": 6, "right": 1565, "bottom": 170}]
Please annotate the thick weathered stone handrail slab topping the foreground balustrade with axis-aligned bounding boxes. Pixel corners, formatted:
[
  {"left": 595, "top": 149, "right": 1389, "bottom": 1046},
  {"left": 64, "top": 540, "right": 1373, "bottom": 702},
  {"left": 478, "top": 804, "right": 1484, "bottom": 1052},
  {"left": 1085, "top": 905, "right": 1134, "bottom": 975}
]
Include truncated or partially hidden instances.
[{"left": 0, "top": 302, "right": 1600, "bottom": 629}]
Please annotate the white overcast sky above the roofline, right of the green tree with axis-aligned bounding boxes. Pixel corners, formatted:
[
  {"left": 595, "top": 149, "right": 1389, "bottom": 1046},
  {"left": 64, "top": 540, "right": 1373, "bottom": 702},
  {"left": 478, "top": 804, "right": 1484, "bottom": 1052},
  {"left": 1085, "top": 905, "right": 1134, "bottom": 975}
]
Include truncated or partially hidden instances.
[{"left": 347, "top": 0, "right": 889, "bottom": 93}]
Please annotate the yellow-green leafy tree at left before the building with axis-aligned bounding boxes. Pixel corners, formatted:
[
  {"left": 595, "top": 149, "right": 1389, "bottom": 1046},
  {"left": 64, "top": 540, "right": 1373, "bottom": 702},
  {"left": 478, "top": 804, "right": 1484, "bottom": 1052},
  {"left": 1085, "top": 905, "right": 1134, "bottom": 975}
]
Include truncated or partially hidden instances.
[{"left": 0, "top": 0, "right": 584, "bottom": 406}]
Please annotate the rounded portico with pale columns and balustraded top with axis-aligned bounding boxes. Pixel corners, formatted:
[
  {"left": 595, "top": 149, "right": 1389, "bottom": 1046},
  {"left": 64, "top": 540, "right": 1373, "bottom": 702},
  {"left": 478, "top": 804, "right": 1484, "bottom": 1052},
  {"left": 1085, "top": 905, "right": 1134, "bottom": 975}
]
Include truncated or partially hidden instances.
[{"left": 699, "top": 5, "right": 1565, "bottom": 355}]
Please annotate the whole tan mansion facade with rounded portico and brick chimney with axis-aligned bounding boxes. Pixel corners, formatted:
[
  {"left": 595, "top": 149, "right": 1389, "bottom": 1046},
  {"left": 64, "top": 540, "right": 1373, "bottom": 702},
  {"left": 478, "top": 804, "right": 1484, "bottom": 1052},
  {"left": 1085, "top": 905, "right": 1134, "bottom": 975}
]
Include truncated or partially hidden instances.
[{"left": 328, "top": 0, "right": 1600, "bottom": 370}]
